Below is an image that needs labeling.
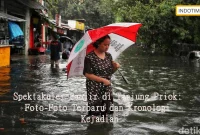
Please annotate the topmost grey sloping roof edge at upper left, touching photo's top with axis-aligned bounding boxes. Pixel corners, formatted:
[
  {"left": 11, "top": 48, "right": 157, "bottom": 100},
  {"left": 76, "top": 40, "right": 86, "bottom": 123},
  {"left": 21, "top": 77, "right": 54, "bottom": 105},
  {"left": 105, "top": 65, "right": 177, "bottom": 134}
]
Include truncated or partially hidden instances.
[{"left": 17, "top": 0, "right": 47, "bottom": 9}]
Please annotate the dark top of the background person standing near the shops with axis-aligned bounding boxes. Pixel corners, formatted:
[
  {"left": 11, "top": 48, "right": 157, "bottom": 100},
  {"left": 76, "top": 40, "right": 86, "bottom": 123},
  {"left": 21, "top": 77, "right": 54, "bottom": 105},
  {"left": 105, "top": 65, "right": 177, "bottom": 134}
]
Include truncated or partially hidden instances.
[{"left": 50, "top": 41, "right": 62, "bottom": 61}]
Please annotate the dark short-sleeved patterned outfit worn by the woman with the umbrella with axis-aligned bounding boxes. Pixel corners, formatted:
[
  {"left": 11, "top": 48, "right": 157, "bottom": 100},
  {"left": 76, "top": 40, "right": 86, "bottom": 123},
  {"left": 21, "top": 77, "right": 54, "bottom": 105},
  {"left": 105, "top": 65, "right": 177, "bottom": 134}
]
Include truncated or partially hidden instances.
[{"left": 83, "top": 51, "right": 113, "bottom": 115}]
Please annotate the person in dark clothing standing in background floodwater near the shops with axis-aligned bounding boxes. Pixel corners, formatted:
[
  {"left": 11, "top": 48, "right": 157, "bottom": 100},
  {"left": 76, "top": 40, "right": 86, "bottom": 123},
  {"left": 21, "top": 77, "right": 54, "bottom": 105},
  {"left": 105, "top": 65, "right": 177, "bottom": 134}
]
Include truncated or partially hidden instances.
[{"left": 50, "top": 32, "right": 62, "bottom": 68}]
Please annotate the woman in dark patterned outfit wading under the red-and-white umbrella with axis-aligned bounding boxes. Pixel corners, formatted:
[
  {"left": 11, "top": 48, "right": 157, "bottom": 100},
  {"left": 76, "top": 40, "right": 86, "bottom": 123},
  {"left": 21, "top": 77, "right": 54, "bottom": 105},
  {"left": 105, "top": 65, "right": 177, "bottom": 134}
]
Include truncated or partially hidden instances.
[{"left": 83, "top": 35, "right": 120, "bottom": 116}]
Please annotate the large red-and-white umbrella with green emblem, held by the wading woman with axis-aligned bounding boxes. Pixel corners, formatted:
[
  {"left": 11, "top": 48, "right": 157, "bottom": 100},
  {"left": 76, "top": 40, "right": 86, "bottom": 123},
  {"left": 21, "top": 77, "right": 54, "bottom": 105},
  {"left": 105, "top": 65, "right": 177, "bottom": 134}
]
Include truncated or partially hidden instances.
[{"left": 67, "top": 23, "right": 142, "bottom": 78}]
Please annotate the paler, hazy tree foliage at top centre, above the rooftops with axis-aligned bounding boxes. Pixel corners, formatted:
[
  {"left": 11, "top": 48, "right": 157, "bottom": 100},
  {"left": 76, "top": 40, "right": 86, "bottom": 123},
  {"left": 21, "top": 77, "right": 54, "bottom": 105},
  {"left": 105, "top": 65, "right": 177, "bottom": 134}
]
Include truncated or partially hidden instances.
[{"left": 47, "top": 0, "right": 114, "bottom": 28}]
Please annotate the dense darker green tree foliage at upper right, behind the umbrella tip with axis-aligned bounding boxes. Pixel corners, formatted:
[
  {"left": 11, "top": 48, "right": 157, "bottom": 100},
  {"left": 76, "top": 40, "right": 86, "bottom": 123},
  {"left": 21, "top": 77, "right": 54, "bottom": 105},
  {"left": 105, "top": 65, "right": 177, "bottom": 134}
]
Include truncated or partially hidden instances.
[{"left": 113, "top": 0, "right": 200, "bottom": 52}]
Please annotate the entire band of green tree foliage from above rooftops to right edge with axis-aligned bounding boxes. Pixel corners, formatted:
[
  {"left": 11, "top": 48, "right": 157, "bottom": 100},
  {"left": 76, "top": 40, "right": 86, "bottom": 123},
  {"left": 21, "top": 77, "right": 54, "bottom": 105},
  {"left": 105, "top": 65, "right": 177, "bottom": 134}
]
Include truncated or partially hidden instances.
[{"left": 48, "top": 0, "right": 200, "bottom": 52}]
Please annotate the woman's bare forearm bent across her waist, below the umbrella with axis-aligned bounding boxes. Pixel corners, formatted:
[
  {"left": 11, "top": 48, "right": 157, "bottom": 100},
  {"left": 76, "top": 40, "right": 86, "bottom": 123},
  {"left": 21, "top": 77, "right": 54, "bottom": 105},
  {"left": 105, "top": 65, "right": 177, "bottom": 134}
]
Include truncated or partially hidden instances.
[{"left": 85, "top": 73, "right": 111, "bottom": 85}]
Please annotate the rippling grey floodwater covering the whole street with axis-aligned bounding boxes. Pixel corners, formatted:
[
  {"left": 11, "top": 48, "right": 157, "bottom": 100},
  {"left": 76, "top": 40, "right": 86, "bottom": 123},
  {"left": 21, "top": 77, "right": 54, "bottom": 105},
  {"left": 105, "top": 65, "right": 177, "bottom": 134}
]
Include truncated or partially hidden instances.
[{"left": 0, "top": 48, "right": 200, "bottom": 135}]
